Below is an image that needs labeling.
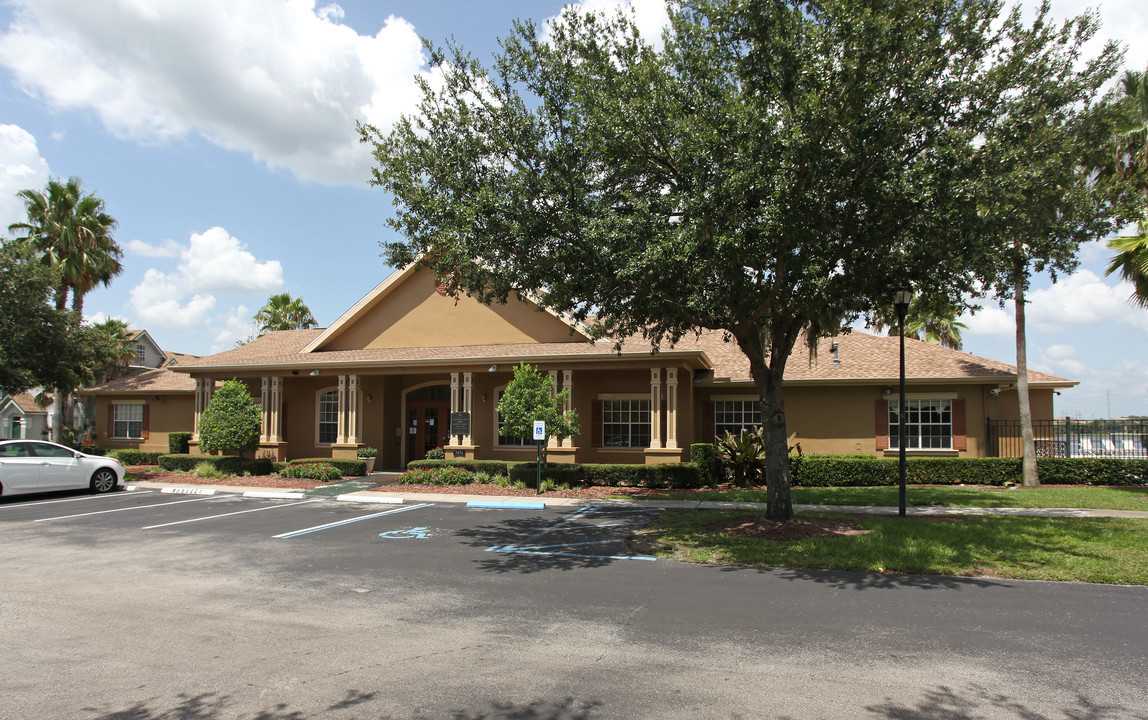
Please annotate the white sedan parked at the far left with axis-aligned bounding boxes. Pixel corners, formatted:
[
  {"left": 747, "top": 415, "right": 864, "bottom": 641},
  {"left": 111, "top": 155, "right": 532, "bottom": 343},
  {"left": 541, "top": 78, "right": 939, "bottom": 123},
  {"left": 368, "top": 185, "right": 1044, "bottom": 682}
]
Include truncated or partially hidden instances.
[{"left": 0, "top": 440, "right": 124, "bottom": 495}]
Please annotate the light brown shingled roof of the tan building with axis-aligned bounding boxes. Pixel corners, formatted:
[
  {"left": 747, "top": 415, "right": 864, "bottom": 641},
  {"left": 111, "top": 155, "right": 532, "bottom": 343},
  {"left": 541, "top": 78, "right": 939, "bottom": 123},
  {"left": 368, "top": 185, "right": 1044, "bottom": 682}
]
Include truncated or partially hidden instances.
[{"left": 172, "top": 328, "right": 1076, "bottom": 388}]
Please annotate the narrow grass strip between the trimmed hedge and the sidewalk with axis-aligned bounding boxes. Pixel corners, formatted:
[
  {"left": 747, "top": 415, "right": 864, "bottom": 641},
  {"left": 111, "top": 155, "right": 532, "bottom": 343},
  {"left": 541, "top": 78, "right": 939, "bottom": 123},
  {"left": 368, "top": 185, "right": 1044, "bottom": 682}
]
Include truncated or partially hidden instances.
[{"left": 659, "top": 485, "right": 1148, "bottom": 511}]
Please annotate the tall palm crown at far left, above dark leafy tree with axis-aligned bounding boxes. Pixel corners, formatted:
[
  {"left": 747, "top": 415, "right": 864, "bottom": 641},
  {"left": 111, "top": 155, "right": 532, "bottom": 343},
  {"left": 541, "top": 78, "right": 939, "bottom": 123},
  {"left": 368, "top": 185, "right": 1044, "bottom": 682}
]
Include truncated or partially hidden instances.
[{"left": 8, "top": 178, "right": 123, "bottom": 315}]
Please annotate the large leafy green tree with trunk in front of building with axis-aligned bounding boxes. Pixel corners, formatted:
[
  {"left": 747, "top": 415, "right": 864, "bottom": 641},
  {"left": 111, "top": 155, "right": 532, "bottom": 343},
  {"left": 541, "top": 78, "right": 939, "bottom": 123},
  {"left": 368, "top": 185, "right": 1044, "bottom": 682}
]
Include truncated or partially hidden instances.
[{"left": 362, "top": 0, "right": 1120, "bottom": 520}]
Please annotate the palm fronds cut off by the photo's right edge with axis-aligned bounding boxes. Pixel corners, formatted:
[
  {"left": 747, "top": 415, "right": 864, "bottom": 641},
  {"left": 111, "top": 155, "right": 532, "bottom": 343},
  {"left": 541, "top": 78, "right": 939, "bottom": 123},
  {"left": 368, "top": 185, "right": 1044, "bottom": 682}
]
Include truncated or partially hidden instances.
[{"left": 1106, "top": 64, "right": 1148, "bottom": 308}]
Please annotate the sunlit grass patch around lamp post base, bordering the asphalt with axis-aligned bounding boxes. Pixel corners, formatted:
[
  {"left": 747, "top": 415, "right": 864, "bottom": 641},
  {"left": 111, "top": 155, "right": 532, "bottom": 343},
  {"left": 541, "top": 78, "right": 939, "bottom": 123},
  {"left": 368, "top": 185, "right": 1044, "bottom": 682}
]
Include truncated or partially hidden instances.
[{"left": 636, "top": 510, "right": 1148, "bottom": 584}]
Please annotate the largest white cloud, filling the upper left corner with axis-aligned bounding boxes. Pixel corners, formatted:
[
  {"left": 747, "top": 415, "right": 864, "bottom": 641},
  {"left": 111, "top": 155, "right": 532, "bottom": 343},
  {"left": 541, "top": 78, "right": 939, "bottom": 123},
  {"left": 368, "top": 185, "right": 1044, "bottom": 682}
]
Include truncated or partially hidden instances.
[{"left": 0, "top": 0, "right": 433, "bottom": 184}]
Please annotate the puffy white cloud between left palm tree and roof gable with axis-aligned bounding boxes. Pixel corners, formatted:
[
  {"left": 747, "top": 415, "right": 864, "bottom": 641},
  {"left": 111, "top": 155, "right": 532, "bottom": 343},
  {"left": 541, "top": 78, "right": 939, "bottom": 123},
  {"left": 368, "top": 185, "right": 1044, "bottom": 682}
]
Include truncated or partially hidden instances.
[{"left": 129, "top": 227, "right": 284, "bottom": 339}]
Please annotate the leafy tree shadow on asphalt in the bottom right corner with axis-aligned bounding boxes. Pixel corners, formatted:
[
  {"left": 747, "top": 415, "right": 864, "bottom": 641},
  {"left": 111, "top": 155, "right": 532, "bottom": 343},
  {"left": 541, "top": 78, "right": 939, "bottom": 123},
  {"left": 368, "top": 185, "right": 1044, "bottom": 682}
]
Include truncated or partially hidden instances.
[{"left": 866, "top": 686, "right": 1148, "bottom": 720}]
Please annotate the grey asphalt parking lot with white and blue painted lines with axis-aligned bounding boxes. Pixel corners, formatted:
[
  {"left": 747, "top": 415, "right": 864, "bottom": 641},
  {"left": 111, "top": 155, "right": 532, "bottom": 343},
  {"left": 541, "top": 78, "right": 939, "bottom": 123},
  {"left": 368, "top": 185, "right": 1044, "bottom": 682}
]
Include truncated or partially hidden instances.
[{"left": 0, "top": 487, "right": 1148, "bottom": 720}]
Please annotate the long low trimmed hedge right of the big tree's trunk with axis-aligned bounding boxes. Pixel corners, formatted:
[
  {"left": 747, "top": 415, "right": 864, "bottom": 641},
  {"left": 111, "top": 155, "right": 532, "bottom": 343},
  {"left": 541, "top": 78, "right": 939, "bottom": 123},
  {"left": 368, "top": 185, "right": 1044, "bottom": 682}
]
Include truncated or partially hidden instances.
[{"left": 790, "top": 455, "right": 1148, "bottom": 487}]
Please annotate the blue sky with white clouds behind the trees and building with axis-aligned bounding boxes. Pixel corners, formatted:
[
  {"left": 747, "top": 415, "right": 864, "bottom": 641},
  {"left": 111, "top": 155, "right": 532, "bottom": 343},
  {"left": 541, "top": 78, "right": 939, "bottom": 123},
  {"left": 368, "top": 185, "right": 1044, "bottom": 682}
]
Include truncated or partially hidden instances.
[{"left": 0, "top": 0, "right": 1148, "bottom": 417}]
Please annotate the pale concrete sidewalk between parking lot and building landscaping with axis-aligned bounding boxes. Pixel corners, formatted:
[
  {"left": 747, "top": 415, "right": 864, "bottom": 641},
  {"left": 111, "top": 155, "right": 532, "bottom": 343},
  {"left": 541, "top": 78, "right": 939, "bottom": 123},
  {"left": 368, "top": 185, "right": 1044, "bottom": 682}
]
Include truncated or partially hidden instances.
[{"left": 123, "top": 481, "right": 1148, "bottom": 519}]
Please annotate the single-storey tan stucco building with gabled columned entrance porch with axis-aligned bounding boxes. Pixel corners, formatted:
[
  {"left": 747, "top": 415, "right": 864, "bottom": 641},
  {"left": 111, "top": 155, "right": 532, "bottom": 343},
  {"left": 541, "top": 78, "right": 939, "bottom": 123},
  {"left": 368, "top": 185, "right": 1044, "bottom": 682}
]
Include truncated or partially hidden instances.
[{"left": 91, "top": 261, "right": 1075, "bottom": 470}]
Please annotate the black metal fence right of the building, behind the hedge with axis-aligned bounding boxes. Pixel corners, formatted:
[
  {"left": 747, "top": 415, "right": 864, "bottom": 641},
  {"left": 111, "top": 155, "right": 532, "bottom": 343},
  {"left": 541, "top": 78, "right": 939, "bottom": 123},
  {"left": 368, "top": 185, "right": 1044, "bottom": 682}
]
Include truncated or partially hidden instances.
[{"left": 985, "top": 418, "right": 1148, "bottom": 459}]
